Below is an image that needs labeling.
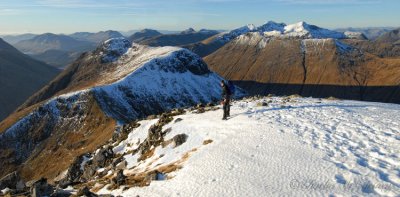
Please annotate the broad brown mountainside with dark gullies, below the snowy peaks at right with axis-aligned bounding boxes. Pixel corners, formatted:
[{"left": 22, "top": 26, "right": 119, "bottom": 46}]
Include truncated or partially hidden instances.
[{"left": 205, "top": 31, "right": 400, "bottom": 103}]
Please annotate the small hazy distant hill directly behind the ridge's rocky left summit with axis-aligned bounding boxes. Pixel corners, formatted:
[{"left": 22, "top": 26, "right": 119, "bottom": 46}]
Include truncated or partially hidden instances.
[{"left": 69, "top": 30, "right": 124, "bottom": 44}]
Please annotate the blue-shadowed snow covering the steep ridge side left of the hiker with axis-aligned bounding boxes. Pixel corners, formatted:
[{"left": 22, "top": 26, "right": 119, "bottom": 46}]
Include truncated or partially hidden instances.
[{"left": 93, "top": 44, "right": 241, "bottom": 121}]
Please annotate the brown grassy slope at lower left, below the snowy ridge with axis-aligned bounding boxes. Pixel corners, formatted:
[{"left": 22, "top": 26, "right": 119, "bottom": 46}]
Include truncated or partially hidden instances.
[{"left": 0, "top": 94, "right": 115, "bottom": 180}]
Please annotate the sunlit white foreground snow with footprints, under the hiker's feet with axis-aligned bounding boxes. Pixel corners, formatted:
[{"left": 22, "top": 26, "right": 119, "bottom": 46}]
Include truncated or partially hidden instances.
[{"left": 99, "top": 97, "right": 400, "bottom": 196}]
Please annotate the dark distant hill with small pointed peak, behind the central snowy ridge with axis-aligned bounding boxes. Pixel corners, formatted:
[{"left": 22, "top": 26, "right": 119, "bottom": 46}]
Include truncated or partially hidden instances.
[{"left": 138, "top": 29, "right": 218, "bottom": 46}]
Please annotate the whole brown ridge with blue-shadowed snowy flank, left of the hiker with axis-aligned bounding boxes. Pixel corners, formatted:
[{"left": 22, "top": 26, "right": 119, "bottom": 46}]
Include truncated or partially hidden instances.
[{"left": 0, "top": 38, "right": 238, "bottom": 183}]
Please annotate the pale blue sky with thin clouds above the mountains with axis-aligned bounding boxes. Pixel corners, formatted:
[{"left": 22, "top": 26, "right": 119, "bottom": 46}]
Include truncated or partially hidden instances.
[{"left": 0, "top": 0, "right": 400, "bottom": 34}]
